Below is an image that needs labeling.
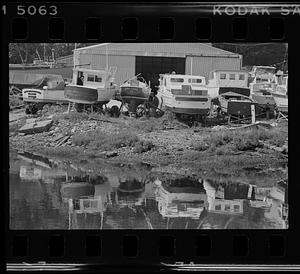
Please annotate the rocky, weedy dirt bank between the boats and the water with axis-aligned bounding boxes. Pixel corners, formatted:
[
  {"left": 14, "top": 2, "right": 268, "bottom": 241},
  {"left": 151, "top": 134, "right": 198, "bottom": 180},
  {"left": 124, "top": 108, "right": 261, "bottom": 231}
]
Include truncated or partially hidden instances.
[{"left": 9, "top": 108, "right": 288, "bottom": 186}]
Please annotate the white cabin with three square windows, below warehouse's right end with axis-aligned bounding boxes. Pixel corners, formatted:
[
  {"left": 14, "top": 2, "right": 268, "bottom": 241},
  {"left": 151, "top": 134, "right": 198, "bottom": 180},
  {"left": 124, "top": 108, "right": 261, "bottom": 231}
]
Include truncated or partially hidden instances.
[{"left": 208, "top": 70, "right": 248, "bottom": 88}]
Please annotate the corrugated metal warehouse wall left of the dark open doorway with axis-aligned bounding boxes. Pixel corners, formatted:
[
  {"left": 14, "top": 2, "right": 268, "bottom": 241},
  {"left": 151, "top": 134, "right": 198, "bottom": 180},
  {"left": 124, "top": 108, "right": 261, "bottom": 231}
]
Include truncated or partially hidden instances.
[{"left": 74, "top": 53, "right": 135, "bottom": 85}]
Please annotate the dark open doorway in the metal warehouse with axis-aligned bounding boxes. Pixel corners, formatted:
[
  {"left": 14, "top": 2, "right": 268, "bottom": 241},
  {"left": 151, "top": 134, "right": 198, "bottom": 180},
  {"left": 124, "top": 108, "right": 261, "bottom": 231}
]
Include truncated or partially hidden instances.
[{"left": 135, "top": 56, "right": 185, "bottom": 91}]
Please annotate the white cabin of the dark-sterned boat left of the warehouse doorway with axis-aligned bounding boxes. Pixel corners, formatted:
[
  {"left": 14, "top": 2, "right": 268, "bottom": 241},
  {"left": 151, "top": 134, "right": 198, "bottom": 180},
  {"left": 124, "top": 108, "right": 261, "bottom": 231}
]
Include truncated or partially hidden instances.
[{"left": 73, "top": 68, "right": 114, "bottom": 87}]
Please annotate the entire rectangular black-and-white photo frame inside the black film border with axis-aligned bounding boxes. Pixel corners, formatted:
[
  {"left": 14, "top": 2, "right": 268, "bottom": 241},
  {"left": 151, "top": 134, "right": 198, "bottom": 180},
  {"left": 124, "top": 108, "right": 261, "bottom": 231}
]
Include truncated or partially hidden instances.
[{"left": 9, "top": 43, "right": 289, "bottom": 230}]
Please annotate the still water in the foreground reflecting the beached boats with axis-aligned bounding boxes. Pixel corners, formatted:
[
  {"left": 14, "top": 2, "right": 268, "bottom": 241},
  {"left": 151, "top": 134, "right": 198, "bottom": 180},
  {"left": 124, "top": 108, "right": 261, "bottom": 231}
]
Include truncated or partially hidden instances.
[{"left": 10, "top": 152, "right": 288, "bottom": 229}]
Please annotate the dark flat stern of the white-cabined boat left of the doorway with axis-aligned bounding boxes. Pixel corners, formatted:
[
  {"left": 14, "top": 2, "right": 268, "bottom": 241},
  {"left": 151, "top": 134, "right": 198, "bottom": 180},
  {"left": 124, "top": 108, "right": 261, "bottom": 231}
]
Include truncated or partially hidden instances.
[{"left": 64, "top": 85, "right": 98, "bottom": 104}]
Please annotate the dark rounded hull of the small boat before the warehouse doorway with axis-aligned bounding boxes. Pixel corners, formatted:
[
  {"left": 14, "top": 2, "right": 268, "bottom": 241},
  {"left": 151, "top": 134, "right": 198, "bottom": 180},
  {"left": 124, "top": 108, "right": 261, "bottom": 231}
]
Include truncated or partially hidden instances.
[{"left": 120, "top": 87, "right": 150, "bottom": 112}]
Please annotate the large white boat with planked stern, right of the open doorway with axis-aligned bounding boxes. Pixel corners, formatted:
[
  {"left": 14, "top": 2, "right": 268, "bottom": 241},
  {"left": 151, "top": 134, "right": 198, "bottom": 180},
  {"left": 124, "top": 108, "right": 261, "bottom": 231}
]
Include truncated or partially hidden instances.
[{"left": 157, "top": 74, "right": 211, "bottom": 116}]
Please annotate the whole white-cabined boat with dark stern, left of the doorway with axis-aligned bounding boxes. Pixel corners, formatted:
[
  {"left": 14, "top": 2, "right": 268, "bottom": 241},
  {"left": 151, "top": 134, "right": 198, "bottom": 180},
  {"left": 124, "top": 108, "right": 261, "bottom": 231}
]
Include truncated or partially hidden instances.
[{"left": 64, "top": 67, "right": 116, "bottom": 105}]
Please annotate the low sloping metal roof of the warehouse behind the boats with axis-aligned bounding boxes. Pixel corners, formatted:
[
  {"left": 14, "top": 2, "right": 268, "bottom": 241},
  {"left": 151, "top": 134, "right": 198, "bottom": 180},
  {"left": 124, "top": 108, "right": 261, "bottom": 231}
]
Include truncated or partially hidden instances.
[{"left": 74, "top": 43, "right": 241, "bottom": 57}]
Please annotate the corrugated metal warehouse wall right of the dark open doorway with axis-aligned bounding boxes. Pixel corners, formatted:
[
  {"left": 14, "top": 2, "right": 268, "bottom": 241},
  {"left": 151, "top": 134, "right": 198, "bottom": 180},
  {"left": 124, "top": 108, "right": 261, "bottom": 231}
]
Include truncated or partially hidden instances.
[{"left": 185, "top": 56, "right": 242, "bottom": 81}]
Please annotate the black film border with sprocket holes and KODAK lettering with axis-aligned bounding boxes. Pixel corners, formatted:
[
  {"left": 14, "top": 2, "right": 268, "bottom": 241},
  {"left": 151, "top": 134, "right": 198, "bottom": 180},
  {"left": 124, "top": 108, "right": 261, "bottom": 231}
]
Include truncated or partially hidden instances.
[{"left": 1, "top": 2, "right": 300, "bottom": 272}]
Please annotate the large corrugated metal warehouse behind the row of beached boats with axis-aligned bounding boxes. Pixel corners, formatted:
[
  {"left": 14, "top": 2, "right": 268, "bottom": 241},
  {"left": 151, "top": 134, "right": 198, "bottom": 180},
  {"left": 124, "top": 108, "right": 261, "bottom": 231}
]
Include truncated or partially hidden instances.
[{"left": 74, "top": 43, "right": 242, "bottom": 88}]
